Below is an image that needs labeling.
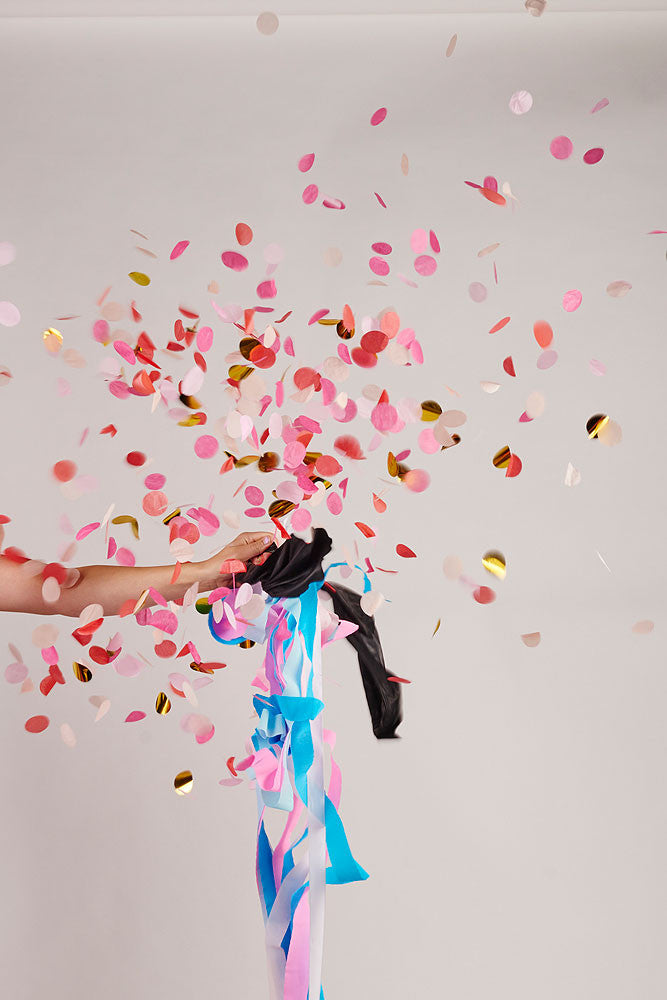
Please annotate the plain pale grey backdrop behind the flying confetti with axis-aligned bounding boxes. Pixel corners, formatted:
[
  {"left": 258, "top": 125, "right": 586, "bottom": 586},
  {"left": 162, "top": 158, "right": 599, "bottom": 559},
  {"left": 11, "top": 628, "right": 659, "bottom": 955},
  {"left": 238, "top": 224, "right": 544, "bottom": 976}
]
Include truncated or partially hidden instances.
[{"left": 0, "top": 11, "right": 667, "bottom": 1000}]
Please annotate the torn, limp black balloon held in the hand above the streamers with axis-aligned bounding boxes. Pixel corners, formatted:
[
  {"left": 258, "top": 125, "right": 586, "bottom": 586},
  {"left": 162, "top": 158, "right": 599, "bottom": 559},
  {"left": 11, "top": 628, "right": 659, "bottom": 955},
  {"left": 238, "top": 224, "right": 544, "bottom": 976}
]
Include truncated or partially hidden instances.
[{"left": 243, "top": 528, "right": 403, "bottom": 740}]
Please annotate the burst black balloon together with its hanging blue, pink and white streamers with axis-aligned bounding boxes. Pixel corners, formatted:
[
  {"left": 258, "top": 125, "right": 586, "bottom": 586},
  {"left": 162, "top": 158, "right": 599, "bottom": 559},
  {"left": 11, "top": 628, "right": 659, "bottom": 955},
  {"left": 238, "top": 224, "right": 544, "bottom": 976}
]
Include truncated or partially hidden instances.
[{"left": 208, "top": 529, "right": 401, "bottom": 1000}]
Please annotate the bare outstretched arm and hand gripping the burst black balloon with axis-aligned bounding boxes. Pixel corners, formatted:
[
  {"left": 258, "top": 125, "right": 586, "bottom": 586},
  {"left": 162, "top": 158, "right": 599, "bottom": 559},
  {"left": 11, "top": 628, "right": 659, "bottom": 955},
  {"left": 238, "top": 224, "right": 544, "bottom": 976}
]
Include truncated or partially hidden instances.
[{"left": 0, "top": 524, "right": 276, "bottom": 618}]
